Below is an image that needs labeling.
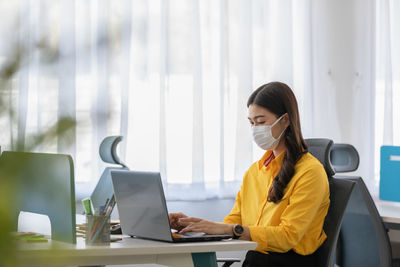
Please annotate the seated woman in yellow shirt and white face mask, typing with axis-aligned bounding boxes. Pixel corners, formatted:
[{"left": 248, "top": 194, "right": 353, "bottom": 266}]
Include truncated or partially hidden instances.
[{"left": 170, "top": 82, "right": 329, "bottom": 267}]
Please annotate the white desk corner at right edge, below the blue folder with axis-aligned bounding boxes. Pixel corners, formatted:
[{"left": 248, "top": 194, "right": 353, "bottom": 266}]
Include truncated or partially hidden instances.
[{"left": 374, "top": 198, "right": 400, "bottom": 230}]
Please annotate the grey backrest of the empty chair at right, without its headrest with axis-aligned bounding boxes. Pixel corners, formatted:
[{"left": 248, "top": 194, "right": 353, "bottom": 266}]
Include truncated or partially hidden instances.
[{"left": 338, "top": 177, "right": 392, "bottom": 267}]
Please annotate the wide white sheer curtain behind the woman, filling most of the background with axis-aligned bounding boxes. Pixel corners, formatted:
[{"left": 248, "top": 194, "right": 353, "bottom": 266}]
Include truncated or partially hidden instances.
[{"left": 1, "top": 0, "right": 375, "bottom": 200}]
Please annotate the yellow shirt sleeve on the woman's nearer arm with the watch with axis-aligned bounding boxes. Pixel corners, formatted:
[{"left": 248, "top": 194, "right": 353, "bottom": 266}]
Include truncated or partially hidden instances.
[{"left": 249, "top": 168, "right": 329, "bottom": 252}]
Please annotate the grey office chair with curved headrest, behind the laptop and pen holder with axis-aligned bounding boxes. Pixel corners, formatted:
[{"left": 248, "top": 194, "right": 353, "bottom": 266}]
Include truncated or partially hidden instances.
[{"left": 90, "top": 136, "right": 129, "bottom": 208}]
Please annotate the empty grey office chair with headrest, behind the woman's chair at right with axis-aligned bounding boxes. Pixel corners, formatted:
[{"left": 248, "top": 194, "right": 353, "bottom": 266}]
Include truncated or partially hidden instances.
[{"left": 330, "top": 144, "right": 400, "bottom": 267}]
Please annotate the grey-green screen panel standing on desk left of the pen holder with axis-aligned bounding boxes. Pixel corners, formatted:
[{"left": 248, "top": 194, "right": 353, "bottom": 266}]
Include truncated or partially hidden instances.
[{"left": 0, "top": 151, "right": 76, "bottom": 243}]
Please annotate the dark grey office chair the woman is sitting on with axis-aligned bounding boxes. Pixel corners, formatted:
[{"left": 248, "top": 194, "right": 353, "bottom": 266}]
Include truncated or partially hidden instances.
[{"left": 306, "top": 139, "right": 354, "bottom": 267}]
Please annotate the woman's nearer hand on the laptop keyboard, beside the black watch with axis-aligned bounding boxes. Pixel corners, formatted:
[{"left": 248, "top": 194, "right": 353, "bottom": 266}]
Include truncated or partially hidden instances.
[{"left": 179, "top": 217, "right": 233, "bottom": 235}]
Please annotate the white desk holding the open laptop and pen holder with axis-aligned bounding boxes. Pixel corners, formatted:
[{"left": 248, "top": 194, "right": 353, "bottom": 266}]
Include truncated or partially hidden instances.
[{"left": 18, "top": 237, "right": 257, "bottom": 267}]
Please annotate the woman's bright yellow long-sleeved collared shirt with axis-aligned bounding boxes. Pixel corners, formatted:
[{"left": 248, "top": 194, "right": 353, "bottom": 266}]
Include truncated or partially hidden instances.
[{"left": 224, "top": 151, "right": 329, "bottom": 255}]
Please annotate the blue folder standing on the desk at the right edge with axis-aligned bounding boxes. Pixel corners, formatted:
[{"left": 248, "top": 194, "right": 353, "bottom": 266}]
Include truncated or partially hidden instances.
[{"left": 379, "top": 146, "right": 400, "bottom": 202}]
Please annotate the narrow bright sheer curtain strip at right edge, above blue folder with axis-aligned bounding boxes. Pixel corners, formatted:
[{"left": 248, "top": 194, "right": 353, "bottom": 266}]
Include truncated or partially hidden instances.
[{"left": 375, "top": 0, "right": 400, "bottom": 186}]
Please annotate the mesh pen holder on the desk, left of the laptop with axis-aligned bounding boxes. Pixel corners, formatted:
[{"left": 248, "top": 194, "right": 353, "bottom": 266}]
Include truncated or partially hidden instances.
[{"left": 86, "top": 215, "right": 110, "bottom": 245}]
